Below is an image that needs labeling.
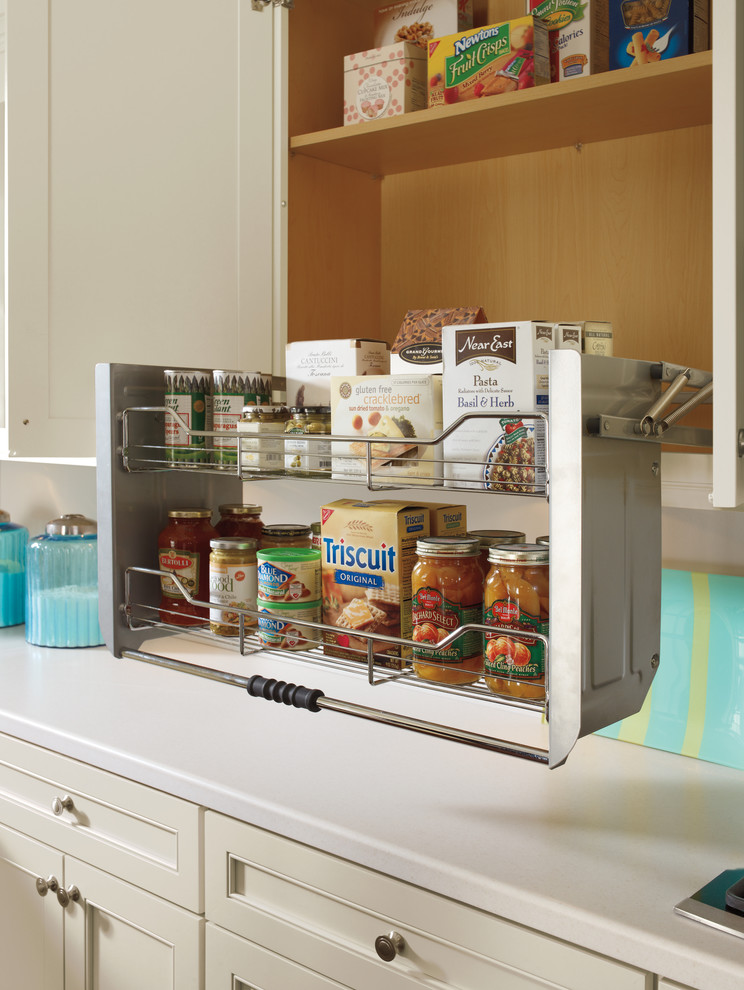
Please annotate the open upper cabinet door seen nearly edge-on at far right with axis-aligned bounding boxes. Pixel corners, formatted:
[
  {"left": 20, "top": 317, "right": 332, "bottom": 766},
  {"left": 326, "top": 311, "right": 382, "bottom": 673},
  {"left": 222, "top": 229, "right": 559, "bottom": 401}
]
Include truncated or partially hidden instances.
[{"left": 711, "top": 0, "right": 744, "bottom": 507}]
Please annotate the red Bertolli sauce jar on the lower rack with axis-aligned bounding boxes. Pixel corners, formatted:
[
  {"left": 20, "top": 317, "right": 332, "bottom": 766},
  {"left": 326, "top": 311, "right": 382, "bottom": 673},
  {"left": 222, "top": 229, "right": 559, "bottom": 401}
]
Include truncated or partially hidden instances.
[{"left": 158, "top": 509, "right": 218, "bottom": 626}]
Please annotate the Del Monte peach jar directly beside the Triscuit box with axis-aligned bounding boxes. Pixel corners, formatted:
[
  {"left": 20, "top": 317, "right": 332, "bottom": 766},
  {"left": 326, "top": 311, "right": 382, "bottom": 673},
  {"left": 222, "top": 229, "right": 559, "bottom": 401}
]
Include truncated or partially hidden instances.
[{"left": 411, "top": 536, "right": 483, "bottom": 684}]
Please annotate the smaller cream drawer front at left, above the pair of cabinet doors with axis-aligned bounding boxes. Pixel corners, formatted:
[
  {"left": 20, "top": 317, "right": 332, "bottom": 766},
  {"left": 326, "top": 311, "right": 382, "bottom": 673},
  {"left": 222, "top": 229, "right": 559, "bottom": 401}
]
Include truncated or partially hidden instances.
[{"left": 0, "top": 736, "right": 204, "bottom": 912}]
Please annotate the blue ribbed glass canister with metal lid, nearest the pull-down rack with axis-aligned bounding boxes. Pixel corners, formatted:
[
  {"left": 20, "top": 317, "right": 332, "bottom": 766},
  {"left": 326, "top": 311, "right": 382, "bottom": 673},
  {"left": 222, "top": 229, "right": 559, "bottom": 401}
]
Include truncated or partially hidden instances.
[{"left": 26, "top": 514, "right": 103, "bottom": 646}]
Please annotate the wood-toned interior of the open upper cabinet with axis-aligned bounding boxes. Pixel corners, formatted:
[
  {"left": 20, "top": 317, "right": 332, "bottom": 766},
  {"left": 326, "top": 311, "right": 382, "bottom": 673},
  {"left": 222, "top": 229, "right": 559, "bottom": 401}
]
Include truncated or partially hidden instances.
[{"left": 288, "top": 0, "right": 712, "bottom": 404}]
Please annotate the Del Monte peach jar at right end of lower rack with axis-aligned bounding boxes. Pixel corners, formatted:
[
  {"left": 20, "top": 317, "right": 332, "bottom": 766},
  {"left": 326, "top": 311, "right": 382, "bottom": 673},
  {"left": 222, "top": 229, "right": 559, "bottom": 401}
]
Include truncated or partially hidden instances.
[{"left": 483, "top": 543, "right": 550, "bottom": 699}]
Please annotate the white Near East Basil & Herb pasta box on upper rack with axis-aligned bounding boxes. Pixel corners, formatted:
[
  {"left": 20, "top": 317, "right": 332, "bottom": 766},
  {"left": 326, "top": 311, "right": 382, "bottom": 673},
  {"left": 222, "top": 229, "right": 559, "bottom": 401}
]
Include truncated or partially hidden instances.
[{"left": 442, "top": 321, "right": 555, "bottom": 494}]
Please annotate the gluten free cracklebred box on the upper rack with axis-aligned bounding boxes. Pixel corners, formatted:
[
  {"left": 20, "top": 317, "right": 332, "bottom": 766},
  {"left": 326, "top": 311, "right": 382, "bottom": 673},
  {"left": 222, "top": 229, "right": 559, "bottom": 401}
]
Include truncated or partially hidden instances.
[{"left": 331, "top": 375, "right": 442, "bottom": 485}]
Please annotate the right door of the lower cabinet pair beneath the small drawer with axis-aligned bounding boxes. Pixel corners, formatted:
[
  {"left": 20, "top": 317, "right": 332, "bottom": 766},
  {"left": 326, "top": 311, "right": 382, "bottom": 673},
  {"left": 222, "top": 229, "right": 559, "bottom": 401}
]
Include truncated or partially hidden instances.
[{"left": 63, "top": 856, "right": 204, "bottom": 990}]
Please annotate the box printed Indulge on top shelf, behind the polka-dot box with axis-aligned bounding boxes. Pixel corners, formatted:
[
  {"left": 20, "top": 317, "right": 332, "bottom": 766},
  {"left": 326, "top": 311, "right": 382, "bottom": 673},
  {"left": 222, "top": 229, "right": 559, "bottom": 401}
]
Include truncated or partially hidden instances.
[{"left": 373, "top": 0, "right": 473, "bottom": 50}]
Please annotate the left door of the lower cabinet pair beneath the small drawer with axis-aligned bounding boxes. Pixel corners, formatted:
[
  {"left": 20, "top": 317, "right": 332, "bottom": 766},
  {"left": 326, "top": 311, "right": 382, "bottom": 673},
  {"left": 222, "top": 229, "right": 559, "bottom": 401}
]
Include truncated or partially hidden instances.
[{"left": 0, "top": 826, "right": 64, "bottom": 990}]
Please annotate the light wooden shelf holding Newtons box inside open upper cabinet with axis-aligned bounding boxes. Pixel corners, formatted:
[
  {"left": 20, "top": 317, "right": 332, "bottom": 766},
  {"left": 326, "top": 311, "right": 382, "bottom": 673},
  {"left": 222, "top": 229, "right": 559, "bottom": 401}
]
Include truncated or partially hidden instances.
[{"left": 290, "top": 51, "right": 713, "bottom": 176}]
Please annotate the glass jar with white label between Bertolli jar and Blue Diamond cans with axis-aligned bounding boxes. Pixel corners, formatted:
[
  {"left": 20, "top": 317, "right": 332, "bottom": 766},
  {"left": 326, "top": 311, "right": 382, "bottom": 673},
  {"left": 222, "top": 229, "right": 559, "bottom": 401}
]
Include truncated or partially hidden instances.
[{"left": 209, "top": 537, "right": 258, "bottom": 636}]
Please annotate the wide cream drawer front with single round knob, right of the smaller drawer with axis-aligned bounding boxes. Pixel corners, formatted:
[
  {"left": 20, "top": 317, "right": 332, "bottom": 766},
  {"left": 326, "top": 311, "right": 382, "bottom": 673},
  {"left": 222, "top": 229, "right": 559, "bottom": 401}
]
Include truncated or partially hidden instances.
[{"left": 205, "top": 812, "right": 653, "bottom": 990}]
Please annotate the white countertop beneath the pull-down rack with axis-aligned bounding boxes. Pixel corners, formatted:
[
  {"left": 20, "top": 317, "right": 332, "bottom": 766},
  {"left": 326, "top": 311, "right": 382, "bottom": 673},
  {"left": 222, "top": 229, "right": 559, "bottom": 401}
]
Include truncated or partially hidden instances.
[{"left": 0, "top": 626, "right": 744, "bottom": 990}]
